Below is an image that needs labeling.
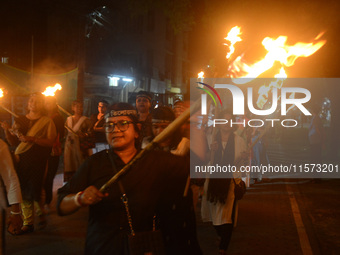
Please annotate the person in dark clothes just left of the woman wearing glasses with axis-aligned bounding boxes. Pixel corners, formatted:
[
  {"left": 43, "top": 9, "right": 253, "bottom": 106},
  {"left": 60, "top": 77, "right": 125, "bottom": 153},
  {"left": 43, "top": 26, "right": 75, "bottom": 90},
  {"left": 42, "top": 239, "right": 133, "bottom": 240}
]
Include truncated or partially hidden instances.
[{"left": 91, "top": 100, "right": 109, "bottom": 154}]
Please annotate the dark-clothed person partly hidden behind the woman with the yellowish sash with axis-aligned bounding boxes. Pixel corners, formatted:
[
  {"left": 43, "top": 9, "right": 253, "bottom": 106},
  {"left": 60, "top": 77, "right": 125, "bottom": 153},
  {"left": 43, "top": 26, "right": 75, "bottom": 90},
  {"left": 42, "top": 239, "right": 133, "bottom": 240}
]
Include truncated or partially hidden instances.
[{"left": 44, "top": 96, "right": 65, "bottom": 210}]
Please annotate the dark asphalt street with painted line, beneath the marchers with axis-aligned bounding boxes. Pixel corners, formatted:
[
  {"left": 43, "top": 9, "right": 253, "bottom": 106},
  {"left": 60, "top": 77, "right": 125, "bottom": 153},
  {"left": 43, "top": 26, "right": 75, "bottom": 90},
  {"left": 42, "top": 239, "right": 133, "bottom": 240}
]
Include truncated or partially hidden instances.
[{"left": 6, "top": 171, "right": 340, "bottom": 255}]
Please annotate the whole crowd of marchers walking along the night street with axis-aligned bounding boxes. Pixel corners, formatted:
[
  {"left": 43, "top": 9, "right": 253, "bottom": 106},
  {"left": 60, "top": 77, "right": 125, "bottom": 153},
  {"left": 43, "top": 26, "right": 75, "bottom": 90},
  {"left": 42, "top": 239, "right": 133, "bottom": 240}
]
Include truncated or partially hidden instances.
[{"left": 0, "top": 91, "right": 324, "bottom": 255}]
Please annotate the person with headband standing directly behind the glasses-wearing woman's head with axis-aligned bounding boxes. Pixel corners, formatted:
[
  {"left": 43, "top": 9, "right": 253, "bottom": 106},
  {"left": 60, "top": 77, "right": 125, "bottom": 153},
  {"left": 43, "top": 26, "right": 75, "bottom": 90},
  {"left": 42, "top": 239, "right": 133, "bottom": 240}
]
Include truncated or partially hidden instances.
[{"left": 136, "top": 91, "right": 152, "bottom": 141}]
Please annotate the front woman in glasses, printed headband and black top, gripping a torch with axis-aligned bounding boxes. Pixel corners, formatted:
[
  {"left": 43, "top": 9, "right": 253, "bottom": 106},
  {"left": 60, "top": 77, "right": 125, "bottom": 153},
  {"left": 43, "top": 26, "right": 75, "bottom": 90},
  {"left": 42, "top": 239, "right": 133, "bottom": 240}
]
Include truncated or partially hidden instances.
[{"left": 57, "top": 103, "right": 204, "bottom": 255}]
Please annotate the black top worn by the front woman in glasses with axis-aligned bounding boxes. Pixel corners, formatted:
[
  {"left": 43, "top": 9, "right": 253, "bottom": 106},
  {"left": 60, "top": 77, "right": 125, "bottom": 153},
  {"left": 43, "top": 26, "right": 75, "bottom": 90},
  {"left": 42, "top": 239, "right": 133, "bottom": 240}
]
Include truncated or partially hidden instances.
[{"left": 58, "top": 150, "right": 192, "bottom": 254}]
